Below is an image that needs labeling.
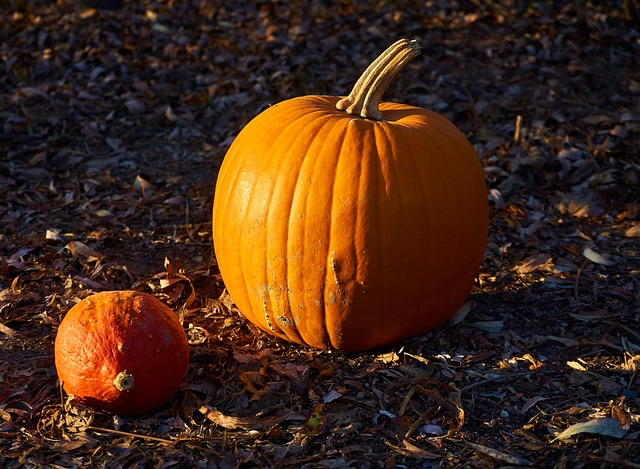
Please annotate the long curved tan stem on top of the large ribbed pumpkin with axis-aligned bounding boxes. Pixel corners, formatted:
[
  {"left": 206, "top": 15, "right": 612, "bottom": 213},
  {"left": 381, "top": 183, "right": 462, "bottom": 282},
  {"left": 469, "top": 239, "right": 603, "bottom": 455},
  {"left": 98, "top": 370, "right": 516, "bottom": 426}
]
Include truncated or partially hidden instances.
[{"left": 336, "top": 39, "right": 420, "bottom": 120}]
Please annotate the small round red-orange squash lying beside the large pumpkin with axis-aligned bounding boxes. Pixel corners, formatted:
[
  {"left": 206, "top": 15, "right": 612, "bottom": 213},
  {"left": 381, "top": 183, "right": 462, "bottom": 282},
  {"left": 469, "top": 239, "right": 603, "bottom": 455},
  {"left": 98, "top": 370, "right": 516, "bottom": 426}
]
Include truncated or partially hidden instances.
[{"left": 55, "top": 291, "right": 189, "bottom": 416}]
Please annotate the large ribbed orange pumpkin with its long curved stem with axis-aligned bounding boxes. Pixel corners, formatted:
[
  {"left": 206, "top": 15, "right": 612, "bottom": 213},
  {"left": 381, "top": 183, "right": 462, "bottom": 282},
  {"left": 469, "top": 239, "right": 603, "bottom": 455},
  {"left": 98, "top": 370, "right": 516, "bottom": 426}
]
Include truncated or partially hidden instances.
[{"left": 213, "top": 40, "right": 488, "bottom": 351}]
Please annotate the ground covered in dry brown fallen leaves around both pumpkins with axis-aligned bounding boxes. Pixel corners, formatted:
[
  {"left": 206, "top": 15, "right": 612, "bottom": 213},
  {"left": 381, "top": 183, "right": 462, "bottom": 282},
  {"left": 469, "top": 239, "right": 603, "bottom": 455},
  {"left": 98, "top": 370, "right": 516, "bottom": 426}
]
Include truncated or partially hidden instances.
[{"left": 0, "top": 0, "right": 640, "bottom": 468}]
